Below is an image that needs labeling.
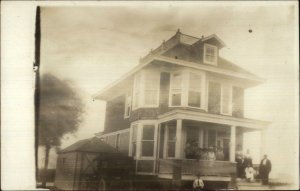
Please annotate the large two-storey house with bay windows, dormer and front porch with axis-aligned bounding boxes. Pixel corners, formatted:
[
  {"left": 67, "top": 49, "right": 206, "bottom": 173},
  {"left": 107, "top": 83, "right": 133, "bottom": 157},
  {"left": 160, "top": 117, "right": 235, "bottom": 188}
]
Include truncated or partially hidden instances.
[{"left": 94, "top": 30, "right": 269, "bottom": 180}]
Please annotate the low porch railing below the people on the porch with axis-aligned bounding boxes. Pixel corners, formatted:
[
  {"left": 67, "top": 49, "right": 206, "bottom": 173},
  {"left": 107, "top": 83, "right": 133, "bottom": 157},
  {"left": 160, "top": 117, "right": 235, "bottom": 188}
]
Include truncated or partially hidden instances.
[{"left": 158, "top": 159, "right": 236, "bottom": 176}]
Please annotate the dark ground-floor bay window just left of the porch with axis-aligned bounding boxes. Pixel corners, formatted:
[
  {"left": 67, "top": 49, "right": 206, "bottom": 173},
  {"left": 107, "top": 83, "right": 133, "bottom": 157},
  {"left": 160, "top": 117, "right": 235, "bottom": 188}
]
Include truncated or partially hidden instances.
[{"left": 141, "top": 125, "right": 155, "bottom": 157}]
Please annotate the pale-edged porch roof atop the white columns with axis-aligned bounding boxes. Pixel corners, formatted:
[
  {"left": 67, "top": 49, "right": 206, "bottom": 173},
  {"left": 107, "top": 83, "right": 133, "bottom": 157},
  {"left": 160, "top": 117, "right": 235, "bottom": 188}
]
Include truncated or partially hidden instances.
[{"left": 158, "top": 109, "right": 270, "bottom": 130}]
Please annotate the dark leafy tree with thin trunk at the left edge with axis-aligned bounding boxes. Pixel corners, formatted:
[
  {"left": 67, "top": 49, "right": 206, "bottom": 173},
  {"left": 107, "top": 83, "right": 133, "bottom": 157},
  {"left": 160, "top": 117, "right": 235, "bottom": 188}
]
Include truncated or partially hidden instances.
[{"left": 38, "top": 74, "right": 84, "bottom": 187}]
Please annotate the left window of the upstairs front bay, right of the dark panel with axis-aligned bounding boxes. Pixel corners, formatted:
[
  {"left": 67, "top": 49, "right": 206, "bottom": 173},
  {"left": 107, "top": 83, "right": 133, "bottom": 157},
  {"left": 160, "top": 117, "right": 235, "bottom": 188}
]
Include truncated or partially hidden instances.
[{"left": 171, "top": 74, "right": 182, "bottom": 106}]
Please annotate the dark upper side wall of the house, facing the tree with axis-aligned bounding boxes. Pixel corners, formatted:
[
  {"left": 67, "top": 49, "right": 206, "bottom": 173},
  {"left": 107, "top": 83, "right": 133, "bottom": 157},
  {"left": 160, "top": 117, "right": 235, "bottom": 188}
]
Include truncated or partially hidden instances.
[{"left": 104, "top": 94, "right": 130, "bottom": 133}]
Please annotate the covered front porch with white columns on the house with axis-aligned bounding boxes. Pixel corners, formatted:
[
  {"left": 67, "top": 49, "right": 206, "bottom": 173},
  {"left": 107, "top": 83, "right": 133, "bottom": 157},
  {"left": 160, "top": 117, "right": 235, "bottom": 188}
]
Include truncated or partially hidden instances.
[{"left": 156, "top": 111, "right": 267, "bottom": 181}]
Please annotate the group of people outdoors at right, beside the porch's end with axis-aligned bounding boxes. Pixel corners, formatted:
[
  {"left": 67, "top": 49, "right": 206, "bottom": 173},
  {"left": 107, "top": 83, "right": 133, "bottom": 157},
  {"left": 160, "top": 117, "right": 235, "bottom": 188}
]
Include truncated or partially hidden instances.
[{"left": 236, "top": 150, "right": 272, "bottom": 185}]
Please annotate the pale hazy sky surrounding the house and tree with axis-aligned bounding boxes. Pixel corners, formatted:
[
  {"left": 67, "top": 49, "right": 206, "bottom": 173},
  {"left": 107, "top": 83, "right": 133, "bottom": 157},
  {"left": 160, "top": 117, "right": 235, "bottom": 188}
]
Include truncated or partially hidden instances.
[{"left": 41, "top": 2, "right": 299, "bottom": 183}]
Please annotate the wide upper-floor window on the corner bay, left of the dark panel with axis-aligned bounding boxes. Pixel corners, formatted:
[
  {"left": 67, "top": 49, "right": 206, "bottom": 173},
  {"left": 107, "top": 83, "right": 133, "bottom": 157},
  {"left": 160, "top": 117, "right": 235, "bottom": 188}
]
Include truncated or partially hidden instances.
[{"left": 144, "top": 73, "right": 159, "bottom": 106}]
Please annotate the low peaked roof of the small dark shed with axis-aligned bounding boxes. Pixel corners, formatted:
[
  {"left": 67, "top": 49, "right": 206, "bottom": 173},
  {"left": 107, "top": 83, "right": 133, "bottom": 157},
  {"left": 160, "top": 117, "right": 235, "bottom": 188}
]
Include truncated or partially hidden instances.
[{"left": 59, "top": 137, "right": 119, "bottom": 153}]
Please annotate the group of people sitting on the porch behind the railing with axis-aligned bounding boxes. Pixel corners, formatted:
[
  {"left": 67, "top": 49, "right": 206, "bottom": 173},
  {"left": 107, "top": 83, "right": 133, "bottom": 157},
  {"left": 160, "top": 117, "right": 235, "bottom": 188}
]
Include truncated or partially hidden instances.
[{"left": 185, "top": 141, "right": 224, "bottom": 160}]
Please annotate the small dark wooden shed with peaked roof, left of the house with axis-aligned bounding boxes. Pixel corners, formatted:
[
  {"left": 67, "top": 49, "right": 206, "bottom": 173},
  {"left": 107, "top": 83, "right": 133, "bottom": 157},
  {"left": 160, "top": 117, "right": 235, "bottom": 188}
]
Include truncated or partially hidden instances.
[{"left": 54, "top": 137, "right": 134, "bottom": 190}]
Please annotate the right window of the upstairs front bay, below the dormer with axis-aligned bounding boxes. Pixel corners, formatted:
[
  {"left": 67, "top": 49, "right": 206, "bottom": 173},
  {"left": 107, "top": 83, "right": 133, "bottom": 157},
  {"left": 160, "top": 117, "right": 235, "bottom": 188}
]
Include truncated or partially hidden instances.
[{"left": 188, "top": 73, "right": 201, "bottom": 107}]
